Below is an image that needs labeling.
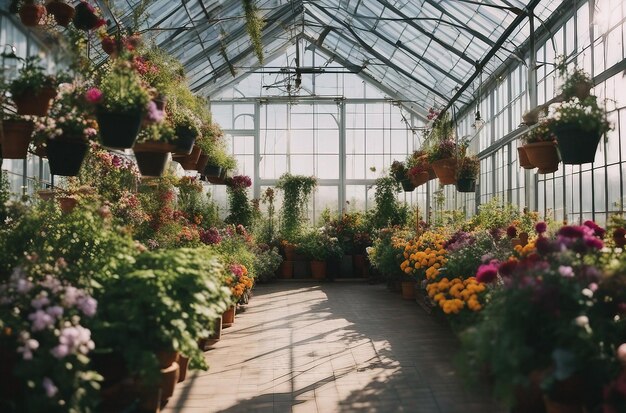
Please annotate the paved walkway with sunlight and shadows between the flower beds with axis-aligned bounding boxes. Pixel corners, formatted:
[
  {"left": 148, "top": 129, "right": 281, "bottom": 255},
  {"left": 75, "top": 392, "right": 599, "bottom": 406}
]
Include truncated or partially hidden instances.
[{"left": 164, "top": 282, "right": 503, "bottom": 413}]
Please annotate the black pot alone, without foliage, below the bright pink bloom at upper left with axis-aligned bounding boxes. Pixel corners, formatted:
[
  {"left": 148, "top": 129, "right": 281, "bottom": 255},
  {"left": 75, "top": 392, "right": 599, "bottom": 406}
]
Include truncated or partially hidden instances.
[{"left": 96, "top": 110, "right": 143, "bottom": 149}]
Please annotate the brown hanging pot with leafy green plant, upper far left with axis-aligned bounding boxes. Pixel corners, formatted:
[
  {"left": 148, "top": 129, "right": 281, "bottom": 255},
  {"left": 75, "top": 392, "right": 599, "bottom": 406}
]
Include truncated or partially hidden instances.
[{"left": 8, "top": 55, "right": 57, "bottom": 116}]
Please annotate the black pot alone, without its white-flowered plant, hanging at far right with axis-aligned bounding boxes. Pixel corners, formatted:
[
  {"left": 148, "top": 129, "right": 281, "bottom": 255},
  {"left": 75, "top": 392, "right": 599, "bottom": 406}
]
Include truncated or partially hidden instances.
[{"left": 554, "top": 125, "right": 600, "bottom": 165}]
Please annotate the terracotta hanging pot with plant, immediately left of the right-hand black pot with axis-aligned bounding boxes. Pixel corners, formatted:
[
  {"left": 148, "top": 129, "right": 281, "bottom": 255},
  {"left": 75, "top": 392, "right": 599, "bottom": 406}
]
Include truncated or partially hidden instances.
[{"left": 522, "top": 119, "right": 560, "bottom": 174}]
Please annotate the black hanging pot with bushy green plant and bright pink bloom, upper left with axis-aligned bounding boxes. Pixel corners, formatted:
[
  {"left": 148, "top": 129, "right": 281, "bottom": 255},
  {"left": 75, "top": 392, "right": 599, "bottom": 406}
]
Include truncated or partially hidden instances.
[{"left": 85, "top": 59, "right": 150, "bottom": 149}]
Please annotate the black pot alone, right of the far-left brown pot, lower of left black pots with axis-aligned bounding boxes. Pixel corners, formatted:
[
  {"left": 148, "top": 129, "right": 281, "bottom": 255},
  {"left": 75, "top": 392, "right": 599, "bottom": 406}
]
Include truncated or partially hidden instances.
[{"left": 47, "top": 136, "right": 89, "bottom": 176}]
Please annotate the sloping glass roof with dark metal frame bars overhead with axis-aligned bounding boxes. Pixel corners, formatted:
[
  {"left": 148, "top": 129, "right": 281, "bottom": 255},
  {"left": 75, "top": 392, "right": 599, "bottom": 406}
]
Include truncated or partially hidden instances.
[{"left": 98, "top": 0, "right": 563, "bottom": 114}]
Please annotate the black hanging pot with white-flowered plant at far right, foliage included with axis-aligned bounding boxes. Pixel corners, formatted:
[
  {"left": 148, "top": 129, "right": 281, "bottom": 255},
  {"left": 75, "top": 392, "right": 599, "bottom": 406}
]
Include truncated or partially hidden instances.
[{"left": 548, "top": 96, "right": 611, "bottom": 165}]
